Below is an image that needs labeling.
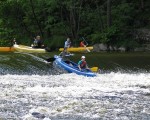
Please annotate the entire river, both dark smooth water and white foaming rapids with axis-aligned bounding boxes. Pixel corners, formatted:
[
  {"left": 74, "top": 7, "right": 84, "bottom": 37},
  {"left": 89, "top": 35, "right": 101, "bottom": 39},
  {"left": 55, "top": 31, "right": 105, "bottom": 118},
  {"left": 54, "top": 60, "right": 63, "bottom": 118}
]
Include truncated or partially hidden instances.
[{"left": 0, "top": 53, "right": 150, "bottom": 120}]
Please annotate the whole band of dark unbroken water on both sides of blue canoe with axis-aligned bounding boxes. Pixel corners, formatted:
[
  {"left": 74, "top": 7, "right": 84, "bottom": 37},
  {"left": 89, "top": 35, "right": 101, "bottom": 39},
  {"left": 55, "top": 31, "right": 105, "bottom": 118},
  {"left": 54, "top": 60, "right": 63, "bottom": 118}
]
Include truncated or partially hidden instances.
[{"left": 0, "top": 52, "right": 150, "bottom": 75}]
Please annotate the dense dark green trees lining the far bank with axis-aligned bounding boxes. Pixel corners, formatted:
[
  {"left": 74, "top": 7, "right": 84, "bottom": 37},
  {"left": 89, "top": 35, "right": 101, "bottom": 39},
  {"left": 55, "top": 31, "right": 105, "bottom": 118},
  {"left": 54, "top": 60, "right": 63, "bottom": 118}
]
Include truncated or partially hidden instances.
[{"left": 0, "top": 0, "right": 150, "bottom": 48}]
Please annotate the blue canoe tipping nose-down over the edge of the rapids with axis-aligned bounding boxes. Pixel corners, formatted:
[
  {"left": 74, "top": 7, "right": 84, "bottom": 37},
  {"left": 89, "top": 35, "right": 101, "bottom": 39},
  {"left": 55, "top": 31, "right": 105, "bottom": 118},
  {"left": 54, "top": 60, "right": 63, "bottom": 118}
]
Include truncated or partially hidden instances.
[{"left": 54, "top": 55, "right": 96, "bottom": 77}]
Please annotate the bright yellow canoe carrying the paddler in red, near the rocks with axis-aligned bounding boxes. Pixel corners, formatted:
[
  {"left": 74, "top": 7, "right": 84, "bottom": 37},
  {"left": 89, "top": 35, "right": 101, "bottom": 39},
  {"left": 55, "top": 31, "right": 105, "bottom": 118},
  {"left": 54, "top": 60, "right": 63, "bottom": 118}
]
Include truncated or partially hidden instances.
[{"left": 59, "top": 46, "right": 93, "bottom": 52}]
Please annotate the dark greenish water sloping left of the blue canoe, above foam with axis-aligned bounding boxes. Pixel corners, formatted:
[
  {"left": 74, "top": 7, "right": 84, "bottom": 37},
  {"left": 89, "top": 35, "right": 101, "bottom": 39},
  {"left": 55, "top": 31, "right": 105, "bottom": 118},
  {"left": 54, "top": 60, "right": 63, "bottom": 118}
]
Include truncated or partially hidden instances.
[{"left": 0, "top": 53, "right": 53, "bottom": 75}]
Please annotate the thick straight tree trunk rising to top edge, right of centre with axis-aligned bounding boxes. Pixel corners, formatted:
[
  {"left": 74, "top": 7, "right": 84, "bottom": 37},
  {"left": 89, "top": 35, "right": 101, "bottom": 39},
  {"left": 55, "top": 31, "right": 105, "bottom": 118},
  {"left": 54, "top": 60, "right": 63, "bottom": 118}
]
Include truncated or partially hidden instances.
[{"left": 107, "top": 0, "right": 112, "bottom": 27}]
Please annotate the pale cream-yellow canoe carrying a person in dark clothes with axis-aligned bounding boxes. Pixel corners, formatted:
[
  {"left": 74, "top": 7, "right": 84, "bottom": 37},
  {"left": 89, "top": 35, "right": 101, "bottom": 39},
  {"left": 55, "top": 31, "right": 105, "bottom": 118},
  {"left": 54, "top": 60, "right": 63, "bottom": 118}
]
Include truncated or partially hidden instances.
[{"left": 14, "top": 45, "right": 46, "bottom": 53}]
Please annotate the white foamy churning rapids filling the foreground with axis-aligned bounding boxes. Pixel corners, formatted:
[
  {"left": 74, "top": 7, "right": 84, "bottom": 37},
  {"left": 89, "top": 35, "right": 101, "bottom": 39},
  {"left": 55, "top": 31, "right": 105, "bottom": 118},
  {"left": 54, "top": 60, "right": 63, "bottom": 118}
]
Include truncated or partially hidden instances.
[{"left": 0, "top": 73, "right": 150, "bottom": 120}]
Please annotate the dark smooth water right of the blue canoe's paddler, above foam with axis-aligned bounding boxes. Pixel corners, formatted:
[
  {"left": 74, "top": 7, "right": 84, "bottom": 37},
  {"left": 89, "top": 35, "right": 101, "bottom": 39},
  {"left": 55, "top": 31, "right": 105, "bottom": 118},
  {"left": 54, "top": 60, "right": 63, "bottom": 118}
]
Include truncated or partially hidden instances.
[{"left": 69, "top": 52, "right": 150, "bottom": 72}]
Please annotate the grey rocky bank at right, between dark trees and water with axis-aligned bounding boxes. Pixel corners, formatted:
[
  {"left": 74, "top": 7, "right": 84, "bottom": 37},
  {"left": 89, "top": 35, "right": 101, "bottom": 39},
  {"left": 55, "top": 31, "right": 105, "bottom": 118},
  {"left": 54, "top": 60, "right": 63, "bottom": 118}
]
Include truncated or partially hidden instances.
[{"left": 93, "top": 28, "right": 150, "bottom": 52}]
